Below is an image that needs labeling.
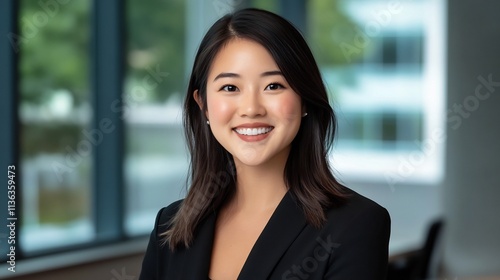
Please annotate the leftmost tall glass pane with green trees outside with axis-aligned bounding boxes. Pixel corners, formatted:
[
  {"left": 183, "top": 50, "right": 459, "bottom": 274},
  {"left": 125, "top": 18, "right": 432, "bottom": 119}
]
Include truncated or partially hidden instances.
[{"left": 18, "top": 0, "right": 93, "bottom": 253}]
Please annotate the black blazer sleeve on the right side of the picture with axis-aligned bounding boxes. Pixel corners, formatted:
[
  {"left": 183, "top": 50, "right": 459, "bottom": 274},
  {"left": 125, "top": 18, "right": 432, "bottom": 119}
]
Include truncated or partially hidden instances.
[{"left": 324, "top": 202, "right": 391, "bottom": 280}]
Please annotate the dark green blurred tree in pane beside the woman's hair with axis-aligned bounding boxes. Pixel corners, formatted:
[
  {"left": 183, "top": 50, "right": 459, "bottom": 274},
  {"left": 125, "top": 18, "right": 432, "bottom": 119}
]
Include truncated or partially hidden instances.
[{"left": 126, "top": 0, "right": 187, "bottom": 102}]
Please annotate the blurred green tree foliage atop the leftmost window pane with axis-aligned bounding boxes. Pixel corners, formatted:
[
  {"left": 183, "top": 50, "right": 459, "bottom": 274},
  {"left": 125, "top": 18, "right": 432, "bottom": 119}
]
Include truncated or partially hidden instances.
[{"left": 18, "top": 0, "right": 90, "bottom": 105}]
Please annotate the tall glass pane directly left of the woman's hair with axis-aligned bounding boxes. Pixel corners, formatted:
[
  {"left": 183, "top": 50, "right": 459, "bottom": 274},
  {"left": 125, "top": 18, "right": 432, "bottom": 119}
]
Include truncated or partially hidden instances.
[{"left": 124, "top": 0, "right": 188, "bottom": 235}]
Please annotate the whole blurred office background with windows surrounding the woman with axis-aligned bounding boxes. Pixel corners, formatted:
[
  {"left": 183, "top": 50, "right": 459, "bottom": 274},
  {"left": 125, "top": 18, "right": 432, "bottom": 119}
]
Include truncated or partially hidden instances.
[{"left": 0, "top": 0, "right": 500, "bottom": 280}]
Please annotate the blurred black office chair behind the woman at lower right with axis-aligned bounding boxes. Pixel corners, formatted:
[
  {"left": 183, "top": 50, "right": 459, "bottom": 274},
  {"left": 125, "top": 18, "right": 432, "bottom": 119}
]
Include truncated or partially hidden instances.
[{"left": 387, "top": 219, "right": 444, "bottom": 280}]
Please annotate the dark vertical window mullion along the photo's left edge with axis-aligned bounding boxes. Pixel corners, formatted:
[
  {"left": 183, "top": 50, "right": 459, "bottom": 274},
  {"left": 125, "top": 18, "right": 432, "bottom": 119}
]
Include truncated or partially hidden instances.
[{"left": 0, "top": 0, "right": 22, "bottom": 262}]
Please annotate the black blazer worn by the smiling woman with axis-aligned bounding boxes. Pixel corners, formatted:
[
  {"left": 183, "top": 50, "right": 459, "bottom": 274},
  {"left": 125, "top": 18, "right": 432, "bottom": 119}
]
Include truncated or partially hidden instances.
[{"left": 139, "top": 189, "right": 390, "bottom": 280}]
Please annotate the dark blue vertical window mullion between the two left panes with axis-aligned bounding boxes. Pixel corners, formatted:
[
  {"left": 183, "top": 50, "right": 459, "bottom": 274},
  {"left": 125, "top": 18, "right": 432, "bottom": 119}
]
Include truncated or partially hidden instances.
[{"left": 91, "top": 0, "right": 124, "bottom": 241}]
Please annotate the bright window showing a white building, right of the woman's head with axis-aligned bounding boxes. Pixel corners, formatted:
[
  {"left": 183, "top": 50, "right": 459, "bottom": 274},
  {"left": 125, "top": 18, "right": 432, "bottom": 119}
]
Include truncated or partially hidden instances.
[{"left": 307, "top": 0, "right": 445, "bottom": 186}]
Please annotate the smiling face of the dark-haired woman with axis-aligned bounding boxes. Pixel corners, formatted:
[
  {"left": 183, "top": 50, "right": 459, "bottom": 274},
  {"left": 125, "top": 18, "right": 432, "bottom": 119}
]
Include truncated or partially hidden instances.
[{"left": 201, "top": 38, "right": 303, "bottom": 166}]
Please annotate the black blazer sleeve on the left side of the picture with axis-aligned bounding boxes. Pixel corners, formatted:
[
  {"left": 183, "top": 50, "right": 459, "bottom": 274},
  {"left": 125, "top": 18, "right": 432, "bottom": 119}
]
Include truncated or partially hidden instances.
[{"left": 139, "top": 201, "right": 181, "bottom": 280}]
